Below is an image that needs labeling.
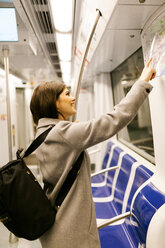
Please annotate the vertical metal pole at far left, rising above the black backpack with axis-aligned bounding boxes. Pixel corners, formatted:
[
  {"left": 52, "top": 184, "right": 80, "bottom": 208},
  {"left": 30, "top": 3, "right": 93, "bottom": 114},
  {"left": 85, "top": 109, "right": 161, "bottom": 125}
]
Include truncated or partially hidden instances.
[{"left": 2, "top": 49, "right": 12, "bottom": 160}]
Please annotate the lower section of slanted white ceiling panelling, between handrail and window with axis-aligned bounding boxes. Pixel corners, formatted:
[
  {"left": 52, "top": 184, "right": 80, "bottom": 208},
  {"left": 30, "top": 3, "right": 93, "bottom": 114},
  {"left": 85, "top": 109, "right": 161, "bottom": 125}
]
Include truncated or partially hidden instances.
[{"left": 86, "top": 30, "right": 141, "bottom": 75}]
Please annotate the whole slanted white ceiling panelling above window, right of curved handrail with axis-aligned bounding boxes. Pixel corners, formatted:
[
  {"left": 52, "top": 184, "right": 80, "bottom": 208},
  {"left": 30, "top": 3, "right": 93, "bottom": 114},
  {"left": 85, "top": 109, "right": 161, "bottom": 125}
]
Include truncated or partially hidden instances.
[{"left": 80, "top": 0, "right": 165, "bottom": 79}]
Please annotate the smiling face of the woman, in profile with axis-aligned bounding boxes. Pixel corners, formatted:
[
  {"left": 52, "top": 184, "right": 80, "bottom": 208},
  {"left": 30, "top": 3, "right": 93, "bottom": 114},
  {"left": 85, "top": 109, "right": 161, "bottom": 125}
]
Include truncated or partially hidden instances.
[{"left": 56, "top": 88, "right": 76, "bottom": 120}]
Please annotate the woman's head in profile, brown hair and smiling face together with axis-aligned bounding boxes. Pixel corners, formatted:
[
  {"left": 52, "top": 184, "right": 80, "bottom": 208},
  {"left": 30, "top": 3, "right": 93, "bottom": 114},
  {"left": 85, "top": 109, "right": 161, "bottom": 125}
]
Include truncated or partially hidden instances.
[{"left": 30, "top": 81, "right": 76, "bottom": 125}]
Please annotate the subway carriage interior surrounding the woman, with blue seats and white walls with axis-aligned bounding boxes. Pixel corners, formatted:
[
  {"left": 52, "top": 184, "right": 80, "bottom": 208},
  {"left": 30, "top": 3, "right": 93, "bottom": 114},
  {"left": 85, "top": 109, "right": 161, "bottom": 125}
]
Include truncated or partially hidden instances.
[{"left": 0, "top": 0, "right": 165, "bottom": 248}]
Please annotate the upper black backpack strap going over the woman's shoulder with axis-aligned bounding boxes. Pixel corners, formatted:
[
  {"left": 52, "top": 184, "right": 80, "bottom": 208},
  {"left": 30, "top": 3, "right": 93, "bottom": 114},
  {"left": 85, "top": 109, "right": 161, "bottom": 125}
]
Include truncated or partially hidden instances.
[{"left": 22, "top": 126, "right": 54, "bottom": 158}]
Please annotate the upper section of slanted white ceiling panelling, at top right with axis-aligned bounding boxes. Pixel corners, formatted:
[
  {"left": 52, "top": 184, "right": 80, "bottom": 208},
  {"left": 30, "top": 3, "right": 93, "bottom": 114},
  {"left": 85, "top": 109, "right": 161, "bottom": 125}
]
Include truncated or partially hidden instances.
[{"left": 107, "top": 5, "right": 160, "bottom": 29}]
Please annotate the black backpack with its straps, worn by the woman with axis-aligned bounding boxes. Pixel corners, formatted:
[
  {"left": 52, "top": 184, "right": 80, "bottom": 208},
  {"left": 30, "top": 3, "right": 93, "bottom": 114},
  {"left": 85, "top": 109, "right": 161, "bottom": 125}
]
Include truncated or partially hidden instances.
[{"left": 0, "top": 126, "right": 83, "bottom": 240}]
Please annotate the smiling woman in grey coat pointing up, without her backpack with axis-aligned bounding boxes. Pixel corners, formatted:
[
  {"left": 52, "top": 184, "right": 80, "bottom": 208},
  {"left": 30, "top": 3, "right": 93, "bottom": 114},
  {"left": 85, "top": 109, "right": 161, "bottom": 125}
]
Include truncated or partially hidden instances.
[{"left": 30, "top": 60, "right": 155, "bottom": 248}]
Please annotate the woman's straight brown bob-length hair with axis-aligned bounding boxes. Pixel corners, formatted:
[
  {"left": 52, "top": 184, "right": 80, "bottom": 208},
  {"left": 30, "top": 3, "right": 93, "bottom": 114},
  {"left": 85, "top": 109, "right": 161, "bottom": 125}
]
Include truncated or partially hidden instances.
[{"left": 30, "top": 81, "right": 66, "bottom": 125}]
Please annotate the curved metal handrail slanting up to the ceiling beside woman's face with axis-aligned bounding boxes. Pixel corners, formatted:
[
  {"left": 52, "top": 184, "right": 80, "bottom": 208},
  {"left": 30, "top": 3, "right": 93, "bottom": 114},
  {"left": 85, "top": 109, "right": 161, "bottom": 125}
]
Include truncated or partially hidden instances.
[{"left": 72, "top": 9, "right": 102, "bottom": 121}]
